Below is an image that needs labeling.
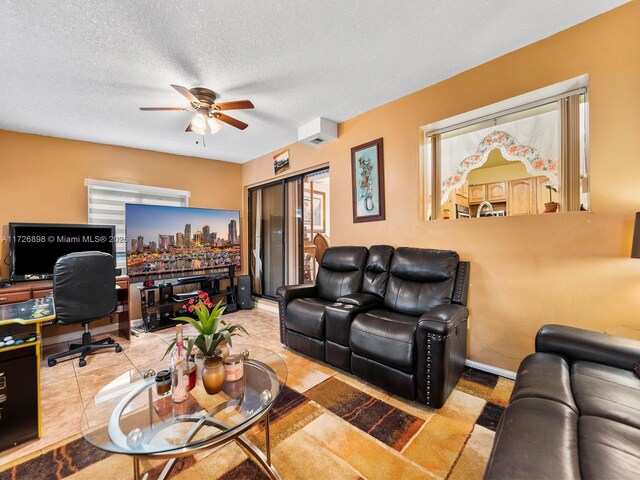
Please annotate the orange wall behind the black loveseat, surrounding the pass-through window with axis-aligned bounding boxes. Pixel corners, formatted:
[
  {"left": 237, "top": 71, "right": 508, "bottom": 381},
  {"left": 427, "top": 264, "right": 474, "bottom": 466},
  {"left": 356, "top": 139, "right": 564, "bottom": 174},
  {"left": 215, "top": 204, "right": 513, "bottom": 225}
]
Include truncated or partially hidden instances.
[{"left": 242, "top": 2, "right": 640, "bottom": 370}]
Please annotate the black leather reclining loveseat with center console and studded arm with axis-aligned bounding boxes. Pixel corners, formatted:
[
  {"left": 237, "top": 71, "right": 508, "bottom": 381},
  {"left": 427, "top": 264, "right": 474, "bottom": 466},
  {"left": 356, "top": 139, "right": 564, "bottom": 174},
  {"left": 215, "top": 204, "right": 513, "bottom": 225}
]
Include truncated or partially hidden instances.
[{"left": 277, "top": 245, "right": 469, "bottom": 408}]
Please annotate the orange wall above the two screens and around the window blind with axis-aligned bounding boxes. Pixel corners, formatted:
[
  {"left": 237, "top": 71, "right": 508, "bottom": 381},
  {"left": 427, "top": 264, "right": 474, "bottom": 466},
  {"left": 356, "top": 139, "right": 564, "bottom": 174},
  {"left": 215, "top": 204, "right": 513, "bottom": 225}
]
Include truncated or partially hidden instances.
[{"left": 0, "top": 130, "right": 243, "bottom": 319}]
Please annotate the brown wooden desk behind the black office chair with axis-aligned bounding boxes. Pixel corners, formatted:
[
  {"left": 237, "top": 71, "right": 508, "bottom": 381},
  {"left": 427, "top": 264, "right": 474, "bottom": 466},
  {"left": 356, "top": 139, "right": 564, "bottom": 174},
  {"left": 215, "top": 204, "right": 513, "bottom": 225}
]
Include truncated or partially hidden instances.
[{"left": 0, "top": 275, "right": 131, "bottom": 340}]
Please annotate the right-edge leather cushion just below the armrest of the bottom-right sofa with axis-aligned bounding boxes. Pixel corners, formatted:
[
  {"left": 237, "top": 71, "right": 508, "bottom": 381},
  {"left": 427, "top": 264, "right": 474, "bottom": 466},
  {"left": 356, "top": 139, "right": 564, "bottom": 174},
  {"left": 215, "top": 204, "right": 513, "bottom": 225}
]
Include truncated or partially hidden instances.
[{"left": 571, "top": 362, "right": 640, "bottom": 429}]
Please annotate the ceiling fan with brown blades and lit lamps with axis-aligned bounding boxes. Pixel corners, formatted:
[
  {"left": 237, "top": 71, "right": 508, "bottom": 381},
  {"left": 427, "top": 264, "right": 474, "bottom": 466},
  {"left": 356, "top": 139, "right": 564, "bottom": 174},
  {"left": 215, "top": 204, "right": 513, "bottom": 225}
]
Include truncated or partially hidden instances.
[{"left": 140, "top": 85, "right": 253, "bottom": 135}]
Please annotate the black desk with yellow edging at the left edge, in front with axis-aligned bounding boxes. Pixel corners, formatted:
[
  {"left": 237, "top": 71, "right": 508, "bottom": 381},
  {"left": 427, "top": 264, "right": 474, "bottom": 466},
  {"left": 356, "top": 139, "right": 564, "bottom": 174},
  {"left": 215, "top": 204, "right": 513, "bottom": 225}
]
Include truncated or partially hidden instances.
[{"left": 0, "top": 295, "right": 55, "bottom": 451}]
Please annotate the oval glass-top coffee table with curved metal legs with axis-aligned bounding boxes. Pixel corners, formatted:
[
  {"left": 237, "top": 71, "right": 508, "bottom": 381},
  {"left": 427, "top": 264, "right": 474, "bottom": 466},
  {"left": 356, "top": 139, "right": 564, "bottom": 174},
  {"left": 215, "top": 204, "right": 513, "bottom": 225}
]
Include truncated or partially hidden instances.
[{"left": 81, "top": 346, "right": 287, "bottom": 480}]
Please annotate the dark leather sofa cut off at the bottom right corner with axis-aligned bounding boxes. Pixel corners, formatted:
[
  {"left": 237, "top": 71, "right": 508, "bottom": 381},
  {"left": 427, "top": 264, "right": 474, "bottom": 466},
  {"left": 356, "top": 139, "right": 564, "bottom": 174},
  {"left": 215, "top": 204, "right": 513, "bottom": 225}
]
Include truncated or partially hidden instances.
[{"left": 484, "top": 325, "right": 640, "bottom": 480}]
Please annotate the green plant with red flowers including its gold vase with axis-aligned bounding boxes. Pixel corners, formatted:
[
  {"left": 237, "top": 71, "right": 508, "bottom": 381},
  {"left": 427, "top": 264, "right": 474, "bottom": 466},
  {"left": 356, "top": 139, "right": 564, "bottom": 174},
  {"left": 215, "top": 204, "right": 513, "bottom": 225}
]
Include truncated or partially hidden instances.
[{"left": 165, "top": 291, "right": 247, "bottom": 394}]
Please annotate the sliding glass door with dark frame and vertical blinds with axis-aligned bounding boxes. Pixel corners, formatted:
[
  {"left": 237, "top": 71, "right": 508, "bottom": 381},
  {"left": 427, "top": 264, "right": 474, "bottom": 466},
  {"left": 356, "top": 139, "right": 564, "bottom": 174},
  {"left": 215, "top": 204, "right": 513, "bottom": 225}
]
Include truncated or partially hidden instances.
[{"left": 249, "top": 169, "right": 328, "bottom": 298}]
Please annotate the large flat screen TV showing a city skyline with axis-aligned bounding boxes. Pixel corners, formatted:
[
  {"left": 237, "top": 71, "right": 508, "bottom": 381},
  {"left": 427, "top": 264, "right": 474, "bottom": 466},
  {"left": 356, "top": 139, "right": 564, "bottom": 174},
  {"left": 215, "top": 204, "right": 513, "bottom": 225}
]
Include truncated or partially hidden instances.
[{"left": 125, "top": 204, "right": 240, "bottom": 282}]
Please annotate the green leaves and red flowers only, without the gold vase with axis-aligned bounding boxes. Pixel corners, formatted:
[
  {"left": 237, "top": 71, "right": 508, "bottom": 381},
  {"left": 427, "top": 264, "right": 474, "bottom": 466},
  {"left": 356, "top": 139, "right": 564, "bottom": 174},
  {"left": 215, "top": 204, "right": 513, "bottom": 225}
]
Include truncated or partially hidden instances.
[{"left": 163, "top": 291, "right": 247, "bottom": 358}]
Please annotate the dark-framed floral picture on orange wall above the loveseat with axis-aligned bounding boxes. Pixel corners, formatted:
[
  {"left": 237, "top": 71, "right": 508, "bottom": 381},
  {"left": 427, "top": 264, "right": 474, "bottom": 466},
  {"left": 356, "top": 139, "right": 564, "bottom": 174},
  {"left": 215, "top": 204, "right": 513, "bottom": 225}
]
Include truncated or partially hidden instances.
[{"left": 351, "top": 138, "right": 385, "bottom": 223}]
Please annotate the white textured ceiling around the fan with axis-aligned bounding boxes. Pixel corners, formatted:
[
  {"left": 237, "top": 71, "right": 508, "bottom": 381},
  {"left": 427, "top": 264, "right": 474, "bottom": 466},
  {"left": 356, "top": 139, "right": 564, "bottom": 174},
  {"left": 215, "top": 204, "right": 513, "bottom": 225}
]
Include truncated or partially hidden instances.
[{"left": 0, "top": 0, "right": 626, "bottom": 163}]
